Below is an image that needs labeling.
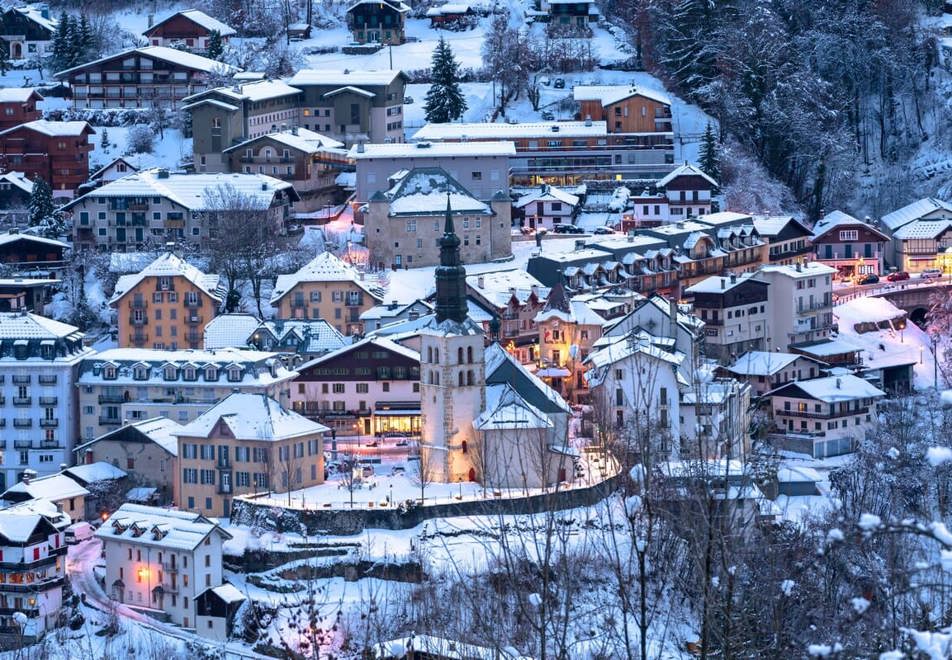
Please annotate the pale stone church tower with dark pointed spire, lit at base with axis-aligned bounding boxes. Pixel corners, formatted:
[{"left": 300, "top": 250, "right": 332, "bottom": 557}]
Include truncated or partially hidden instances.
[{"left": 420, "top": 195, "right": 486, "bottom": 483}]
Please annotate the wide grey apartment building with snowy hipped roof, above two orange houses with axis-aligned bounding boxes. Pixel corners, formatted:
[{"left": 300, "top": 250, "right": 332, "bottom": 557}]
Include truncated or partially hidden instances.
[{"left": 63, "top": 168, "right": 298, "bottom": 252}]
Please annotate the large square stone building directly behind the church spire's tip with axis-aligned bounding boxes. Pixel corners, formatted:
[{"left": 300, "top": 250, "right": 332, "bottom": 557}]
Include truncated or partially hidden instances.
[{"left": 364, "top": 168, "right": 512, "bottom": 269}]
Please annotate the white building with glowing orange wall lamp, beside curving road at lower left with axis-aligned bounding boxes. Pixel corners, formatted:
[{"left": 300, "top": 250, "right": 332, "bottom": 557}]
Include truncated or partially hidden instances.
[{"left": 96, "top": 503, "right": 231, "bottom": 629}]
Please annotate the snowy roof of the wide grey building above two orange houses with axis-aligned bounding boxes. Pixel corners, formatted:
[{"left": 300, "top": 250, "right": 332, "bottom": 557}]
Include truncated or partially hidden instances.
[{"left": 65, "top": 168, "right": 293, "bottom": 211}]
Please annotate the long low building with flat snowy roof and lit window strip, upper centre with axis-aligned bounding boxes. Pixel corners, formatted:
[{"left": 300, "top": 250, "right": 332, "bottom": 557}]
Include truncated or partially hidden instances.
[{"left": 413, "top": 120, "right": 674, "bottom": 185}]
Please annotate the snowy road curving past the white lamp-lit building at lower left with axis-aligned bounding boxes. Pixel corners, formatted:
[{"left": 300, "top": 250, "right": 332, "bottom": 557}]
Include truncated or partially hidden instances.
[{"left": 66, "top": 539, "right": 266, "bottom": 660}]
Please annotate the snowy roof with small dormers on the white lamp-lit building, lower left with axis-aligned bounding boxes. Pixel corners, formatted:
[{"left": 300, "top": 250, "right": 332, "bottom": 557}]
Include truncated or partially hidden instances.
[{"left": 96, "top": 502, "right": 231, "bottom": 550}]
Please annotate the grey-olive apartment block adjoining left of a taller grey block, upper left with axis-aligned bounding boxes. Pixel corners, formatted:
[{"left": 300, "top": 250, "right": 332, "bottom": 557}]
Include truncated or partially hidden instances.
[{"left": 182, "top": 80, "right": 302, "bottom": 172}]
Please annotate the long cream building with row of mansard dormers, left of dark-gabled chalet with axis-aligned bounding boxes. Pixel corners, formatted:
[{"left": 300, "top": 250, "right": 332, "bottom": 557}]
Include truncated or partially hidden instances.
[{"left": 77, "top": 348, "right": 297, "bottom": 442}]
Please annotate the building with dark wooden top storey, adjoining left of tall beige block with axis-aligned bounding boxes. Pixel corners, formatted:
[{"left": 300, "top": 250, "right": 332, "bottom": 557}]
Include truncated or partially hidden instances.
[{"left": 684, "top": 273, "right": 773, "bottom": 364}]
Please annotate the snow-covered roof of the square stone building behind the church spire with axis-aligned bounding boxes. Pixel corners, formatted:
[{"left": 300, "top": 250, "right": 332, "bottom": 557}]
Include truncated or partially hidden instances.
[{"left": 386, "top": 167, "right": 493, "bottom": 217}]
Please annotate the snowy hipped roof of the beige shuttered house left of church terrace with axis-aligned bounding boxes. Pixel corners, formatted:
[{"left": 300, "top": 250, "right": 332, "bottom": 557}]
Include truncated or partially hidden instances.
[{"left": 174, "top": 392, "right": 329, "bottom": 441}]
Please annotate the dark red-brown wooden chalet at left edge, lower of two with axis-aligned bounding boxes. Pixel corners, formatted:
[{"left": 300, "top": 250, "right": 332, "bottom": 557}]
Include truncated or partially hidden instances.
[{"left": 0, "top": 119, "right": 96, "bottom": 197}]
